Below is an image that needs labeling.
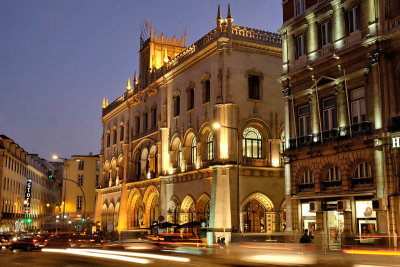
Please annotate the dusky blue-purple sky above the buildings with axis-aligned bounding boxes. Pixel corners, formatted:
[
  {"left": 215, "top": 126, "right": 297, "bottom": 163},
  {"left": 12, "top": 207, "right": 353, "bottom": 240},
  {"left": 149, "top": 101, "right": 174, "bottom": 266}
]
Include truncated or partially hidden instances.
[{"left": 0, "top": 0, "right": 282, "bottom": 159}]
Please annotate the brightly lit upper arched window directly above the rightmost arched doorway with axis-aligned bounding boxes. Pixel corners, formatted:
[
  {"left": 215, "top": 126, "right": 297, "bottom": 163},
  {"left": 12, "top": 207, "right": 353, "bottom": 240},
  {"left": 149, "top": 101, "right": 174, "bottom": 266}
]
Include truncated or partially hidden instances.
[{"left": 243, "top": 127, "right": 262, "bottom": 159}]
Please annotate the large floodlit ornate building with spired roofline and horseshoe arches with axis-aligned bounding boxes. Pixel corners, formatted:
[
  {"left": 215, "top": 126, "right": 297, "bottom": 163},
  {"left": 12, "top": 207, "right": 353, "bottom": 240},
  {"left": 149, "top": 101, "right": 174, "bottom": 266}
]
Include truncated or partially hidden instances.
[{"left": 95, "top": 7, "right": 285, "bottom": 241}]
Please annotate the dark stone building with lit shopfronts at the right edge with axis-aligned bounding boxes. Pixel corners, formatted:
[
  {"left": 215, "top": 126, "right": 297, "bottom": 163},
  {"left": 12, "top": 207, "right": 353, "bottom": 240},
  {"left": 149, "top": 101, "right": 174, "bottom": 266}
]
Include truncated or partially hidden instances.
[{"left": 280, "top": 0, "right": 400, "bottom": 248}]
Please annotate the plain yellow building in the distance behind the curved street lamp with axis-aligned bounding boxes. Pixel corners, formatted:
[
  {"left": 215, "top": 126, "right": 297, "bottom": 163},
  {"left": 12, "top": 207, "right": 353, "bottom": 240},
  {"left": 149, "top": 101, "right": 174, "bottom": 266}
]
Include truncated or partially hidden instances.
[{"left": 57, "top": 153, "right": 100, "bottom": 231}]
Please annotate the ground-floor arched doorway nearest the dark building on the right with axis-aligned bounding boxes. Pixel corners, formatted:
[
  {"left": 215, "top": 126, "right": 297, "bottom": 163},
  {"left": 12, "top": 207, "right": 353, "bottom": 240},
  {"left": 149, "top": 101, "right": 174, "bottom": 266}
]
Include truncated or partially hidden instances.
[{"left": 241, "top": 193, "right": 276, "bottom": 233}]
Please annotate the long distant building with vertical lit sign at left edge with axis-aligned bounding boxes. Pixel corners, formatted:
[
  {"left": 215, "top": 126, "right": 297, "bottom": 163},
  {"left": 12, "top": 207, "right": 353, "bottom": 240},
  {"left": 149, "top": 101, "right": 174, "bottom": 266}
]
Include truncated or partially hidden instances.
[{"left": 0, "top": 135, "right": 60, "bottom": 232}]
